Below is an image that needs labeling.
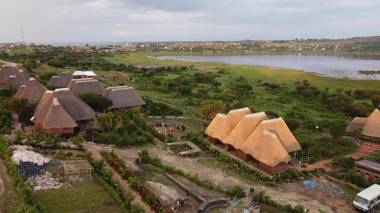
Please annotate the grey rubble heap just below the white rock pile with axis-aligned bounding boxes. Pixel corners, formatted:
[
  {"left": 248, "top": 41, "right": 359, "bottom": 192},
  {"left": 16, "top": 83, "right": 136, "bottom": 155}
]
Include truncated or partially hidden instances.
[{"left": 28, "top": 172, "right": 65, "bottom": 191}]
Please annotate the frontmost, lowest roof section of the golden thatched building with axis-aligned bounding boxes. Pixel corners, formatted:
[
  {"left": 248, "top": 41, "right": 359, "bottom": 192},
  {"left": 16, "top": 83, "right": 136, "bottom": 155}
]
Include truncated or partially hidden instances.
[{"left": 241, "top": 129, "right": 291, "bottom": 167}]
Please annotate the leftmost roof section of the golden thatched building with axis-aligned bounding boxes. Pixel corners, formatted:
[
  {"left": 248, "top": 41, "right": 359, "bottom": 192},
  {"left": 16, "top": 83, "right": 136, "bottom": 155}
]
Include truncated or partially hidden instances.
[{"left": 206, "top": 108, "right": 251, "bottom": 143}]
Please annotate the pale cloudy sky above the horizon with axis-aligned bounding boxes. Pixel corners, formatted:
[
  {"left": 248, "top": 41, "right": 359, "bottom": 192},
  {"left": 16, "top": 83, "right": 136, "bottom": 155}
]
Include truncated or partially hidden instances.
[{"left": 0, "top": 0, "right": 380, "bottom": 43}]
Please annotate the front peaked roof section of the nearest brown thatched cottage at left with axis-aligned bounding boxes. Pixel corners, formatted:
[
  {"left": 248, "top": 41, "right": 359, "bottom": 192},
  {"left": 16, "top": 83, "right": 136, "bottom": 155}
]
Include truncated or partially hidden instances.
[{"left": 42, "top": 98, "right": 78, "bottom": 129}]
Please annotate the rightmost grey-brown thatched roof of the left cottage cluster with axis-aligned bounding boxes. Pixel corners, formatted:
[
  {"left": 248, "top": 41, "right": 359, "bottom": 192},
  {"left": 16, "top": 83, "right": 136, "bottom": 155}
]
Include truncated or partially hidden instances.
[{"left": 104, "top": 86, "right": 145, "bottom": 109}]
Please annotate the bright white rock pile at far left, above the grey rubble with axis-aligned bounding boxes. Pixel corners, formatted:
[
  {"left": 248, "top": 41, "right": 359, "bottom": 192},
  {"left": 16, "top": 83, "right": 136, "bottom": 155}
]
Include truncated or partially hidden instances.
[{"left": 12, "top": 145, "right": 50, "bottom": 166}]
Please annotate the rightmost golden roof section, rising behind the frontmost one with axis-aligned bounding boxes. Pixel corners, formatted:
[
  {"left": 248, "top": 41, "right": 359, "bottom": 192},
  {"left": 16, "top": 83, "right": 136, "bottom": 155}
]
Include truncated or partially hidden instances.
[{"left": 253, "top": 118, "right": 301, "bottom": 153}]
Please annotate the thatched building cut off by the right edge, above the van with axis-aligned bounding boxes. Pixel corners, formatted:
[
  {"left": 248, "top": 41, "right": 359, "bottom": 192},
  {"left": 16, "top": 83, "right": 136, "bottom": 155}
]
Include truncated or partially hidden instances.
[{"left": 346, "top": 109, "right": 380, "bottom": 142}]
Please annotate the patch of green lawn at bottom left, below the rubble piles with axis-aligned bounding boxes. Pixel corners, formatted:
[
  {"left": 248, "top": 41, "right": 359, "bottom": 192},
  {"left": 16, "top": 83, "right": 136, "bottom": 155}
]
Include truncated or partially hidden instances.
[{"left": 34, "top": 182, "right": 121, "bottom": 213}]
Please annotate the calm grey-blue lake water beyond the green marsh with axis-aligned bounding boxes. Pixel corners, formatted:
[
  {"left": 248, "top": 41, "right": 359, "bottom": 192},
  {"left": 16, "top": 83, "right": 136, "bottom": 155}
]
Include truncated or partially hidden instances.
[{"left": 159, "top": 55, "right": 380, "bottom": 79}]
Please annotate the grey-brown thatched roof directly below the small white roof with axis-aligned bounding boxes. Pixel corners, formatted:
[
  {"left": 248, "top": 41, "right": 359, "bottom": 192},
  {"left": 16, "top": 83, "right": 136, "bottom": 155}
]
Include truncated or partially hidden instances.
[{"left": 68, "top": 79, "right": 105, "bottom": 96}]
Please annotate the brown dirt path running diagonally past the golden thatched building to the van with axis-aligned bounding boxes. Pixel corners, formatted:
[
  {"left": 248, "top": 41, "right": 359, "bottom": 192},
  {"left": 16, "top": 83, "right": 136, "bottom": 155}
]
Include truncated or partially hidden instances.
[{"left": 150, "top": 147, "right": 352, "bottom": 213}]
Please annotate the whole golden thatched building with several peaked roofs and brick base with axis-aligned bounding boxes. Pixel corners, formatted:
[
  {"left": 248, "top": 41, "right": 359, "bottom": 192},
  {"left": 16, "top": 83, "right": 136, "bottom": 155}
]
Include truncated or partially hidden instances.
[{"left": 206, "top": 108, "right": 301, "bottom": 174}]
